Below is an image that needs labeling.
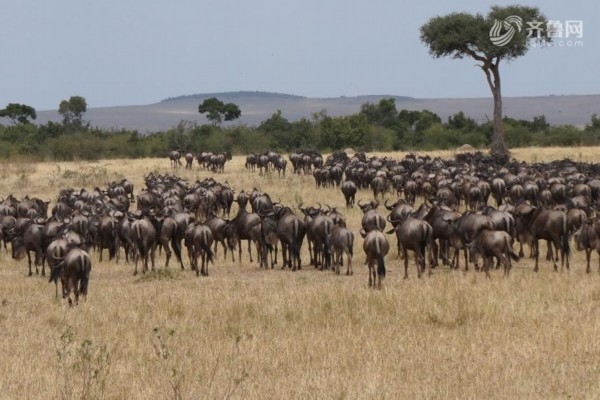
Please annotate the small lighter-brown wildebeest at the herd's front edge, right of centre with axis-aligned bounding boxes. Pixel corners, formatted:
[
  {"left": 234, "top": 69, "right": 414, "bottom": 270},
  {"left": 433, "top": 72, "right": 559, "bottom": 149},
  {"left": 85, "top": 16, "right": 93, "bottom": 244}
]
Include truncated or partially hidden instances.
[{"left": 467, "top": 229, "right": 519, "bottom": 278}]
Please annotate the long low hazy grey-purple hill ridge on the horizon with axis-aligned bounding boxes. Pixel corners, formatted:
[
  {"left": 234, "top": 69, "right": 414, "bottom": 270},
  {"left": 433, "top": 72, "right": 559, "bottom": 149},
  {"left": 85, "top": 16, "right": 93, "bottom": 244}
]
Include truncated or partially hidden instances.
[{"left": 36, "top": 92, "right": 600, "bottom": 133}]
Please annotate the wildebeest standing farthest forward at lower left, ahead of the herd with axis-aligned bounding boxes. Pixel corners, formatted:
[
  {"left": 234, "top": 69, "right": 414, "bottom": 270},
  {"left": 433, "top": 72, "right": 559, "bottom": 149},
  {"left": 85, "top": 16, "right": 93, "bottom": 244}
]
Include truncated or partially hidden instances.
[{"left": 49, "top": 247, "right": 92, "bottom": 306}]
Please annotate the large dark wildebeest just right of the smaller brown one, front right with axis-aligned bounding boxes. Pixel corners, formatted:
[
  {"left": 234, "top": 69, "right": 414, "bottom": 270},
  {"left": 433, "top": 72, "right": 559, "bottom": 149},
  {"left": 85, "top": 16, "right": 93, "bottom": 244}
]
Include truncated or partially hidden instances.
[{"left": 516, "top": 207, "right": 570, "bottom": 272}]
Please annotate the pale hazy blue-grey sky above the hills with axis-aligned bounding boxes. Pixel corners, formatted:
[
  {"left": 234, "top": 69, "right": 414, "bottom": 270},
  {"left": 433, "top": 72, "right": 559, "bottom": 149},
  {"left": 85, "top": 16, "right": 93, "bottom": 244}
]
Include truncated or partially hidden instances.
[{"left": 0, "top": 0, "right": 600, "bottom": 110}]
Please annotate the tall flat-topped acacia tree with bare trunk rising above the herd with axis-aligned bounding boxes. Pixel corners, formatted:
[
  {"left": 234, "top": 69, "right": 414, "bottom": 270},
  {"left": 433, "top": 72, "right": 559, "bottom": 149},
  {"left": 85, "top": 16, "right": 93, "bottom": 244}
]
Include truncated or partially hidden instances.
[{"left": 421, "top": 6, "right": 551, "bottom": 160}]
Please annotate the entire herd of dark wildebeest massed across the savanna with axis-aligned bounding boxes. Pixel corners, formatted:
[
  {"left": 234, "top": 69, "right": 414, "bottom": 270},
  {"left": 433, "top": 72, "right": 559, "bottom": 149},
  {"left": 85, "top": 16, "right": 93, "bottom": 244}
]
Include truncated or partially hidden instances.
[{"left": 0, "top": 151, "right": 600, "bottom": 304}]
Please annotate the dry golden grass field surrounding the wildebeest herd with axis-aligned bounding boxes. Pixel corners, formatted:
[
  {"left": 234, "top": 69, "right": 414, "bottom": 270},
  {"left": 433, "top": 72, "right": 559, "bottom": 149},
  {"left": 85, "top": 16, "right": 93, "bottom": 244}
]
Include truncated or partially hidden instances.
[{"left": 0, "top": 148, "right": 600, "bottom": 399}]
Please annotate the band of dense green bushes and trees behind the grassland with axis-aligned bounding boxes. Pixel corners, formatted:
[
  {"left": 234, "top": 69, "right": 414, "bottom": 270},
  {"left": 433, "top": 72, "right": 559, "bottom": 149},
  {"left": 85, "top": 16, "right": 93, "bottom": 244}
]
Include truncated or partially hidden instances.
[{"left": 0, "top": 98, "right": 600, "bottom": 160}]
